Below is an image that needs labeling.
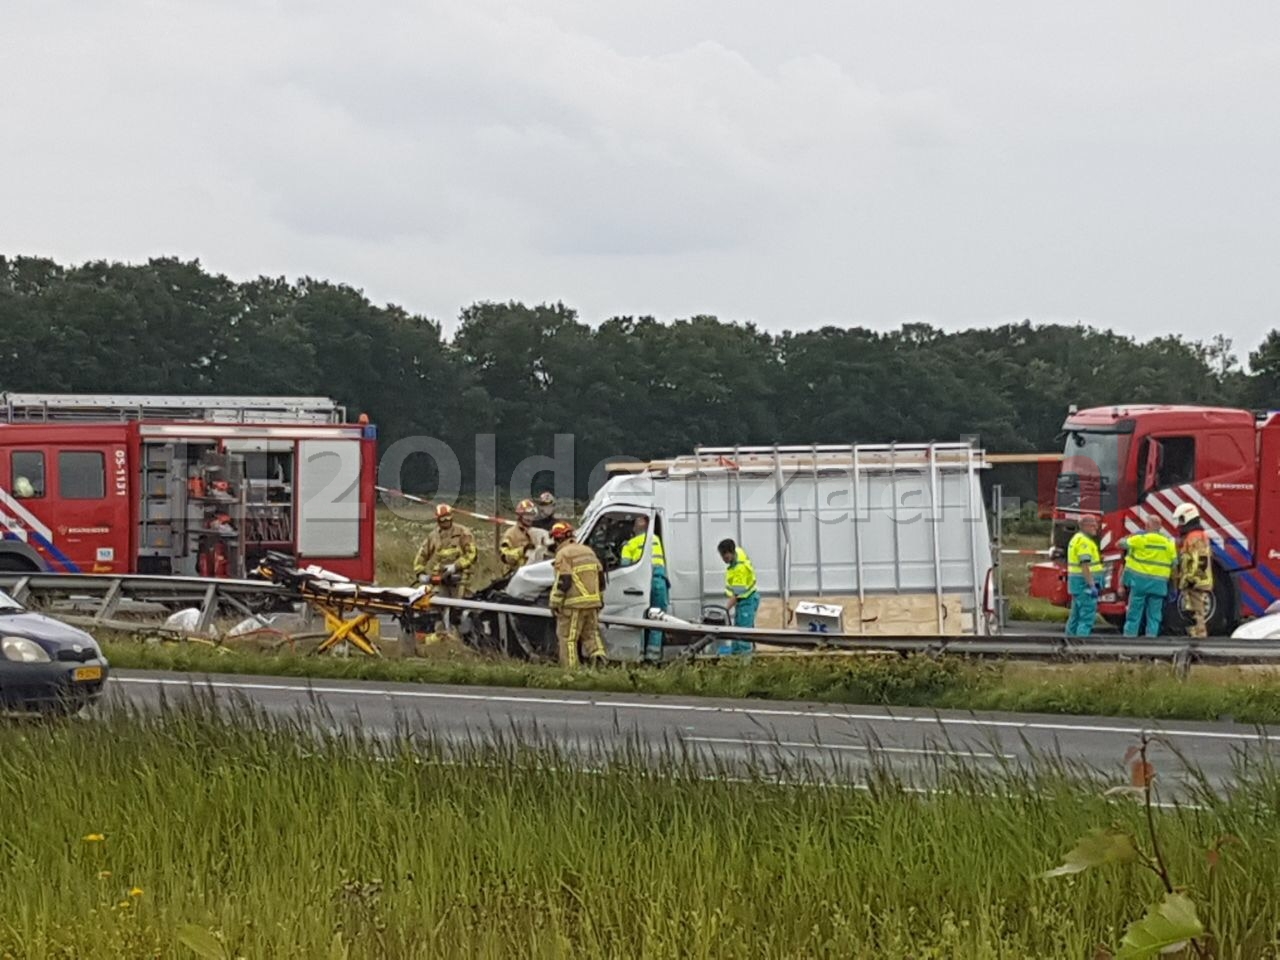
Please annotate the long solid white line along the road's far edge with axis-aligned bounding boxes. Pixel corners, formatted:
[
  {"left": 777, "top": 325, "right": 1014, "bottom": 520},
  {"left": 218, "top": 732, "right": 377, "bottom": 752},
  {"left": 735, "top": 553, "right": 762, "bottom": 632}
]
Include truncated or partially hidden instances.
[{"left": 111, "top": 676, "right": 1275, "bottom": 744}]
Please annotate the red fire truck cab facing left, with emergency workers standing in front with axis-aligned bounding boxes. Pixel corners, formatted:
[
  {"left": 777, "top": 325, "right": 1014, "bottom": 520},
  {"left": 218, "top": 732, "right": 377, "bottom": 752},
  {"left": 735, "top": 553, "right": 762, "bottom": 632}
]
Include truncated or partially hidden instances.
[{"left": 1032, "top": 406, "right": 1280, "bottom": 635}]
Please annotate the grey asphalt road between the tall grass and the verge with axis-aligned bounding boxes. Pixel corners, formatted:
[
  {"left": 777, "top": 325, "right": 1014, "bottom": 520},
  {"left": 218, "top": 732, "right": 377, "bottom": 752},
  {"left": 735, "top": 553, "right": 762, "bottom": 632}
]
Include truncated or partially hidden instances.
[{"left": 110, "top": 671, "right": 1272, "bottom": 799}]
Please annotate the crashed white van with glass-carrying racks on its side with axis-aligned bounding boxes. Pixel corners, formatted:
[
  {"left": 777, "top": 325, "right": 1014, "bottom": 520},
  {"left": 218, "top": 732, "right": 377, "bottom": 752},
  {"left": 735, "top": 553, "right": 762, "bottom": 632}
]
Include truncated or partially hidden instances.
[{"left": 506, "top": 443, "right": 993, "bottom": 659}]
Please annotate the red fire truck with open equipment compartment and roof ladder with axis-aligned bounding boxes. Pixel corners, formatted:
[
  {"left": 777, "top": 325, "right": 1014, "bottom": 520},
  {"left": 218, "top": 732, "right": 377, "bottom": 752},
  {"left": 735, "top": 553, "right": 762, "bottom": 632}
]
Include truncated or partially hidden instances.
[{"left": 0, "top": 393, "right": 378, "bottom": 580}]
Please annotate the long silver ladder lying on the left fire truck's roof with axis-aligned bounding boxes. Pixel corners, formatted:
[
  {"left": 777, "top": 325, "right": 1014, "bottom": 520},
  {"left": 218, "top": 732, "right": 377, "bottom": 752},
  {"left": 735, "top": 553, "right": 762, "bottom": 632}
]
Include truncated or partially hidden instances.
[{"left": 0, "top": 393, "right": 347, "bottom": 424}]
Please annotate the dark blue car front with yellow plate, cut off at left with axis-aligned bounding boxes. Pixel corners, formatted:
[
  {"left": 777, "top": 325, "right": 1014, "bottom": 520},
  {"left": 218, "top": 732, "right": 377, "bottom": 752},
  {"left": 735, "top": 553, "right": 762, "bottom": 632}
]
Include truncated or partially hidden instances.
[{"left": 0, "top": 590, "right": 108, "bottom": 714}]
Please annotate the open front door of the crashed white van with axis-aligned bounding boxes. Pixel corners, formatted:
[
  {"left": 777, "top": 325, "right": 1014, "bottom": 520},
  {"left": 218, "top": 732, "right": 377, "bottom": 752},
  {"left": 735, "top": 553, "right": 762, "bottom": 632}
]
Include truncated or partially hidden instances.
[{"left": 585, "top": 504, "right": 653, "bottom": 660}]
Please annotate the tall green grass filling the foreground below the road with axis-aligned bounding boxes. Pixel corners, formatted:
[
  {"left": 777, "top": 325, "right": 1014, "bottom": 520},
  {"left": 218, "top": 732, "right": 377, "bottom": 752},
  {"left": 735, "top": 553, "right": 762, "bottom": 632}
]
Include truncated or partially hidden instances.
[{"left": 0, "top": 704, "right": 1280, "bottom": 959}]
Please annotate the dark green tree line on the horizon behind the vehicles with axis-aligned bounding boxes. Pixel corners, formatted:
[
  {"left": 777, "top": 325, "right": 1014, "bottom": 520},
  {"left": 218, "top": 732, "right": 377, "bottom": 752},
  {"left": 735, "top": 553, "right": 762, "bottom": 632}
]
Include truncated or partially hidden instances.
[{"left": 0, "top": 256, "right": 1280, "bottom": 504}]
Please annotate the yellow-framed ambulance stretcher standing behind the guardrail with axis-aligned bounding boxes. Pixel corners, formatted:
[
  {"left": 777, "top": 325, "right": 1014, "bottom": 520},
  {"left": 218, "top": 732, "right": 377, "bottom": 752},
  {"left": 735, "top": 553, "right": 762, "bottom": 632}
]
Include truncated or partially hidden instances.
[{"left": 253, "top": 553, "right": 433, "bottom": 657}]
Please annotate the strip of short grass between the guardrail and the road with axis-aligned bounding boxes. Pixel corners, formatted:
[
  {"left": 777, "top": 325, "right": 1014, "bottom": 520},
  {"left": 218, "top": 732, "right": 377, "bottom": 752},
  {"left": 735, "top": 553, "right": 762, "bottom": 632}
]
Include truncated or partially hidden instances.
[{"left": 105, "top": 641, "right": 1280, "bottom": 723}]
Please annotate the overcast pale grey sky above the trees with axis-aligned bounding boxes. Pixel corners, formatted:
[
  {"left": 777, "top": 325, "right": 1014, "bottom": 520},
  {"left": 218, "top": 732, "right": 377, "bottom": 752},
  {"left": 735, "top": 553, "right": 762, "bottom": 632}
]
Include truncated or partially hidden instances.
[{"left": 0, "top": 0, "right": 1280, "bottom": 349}]
